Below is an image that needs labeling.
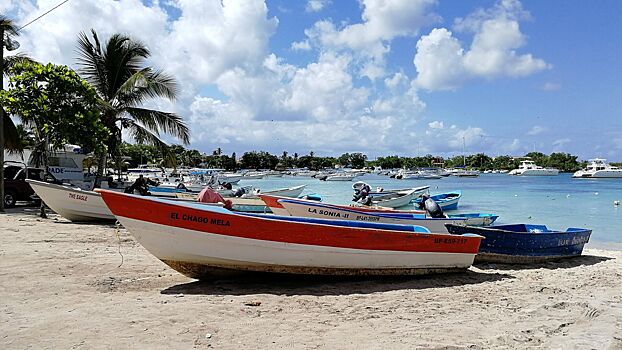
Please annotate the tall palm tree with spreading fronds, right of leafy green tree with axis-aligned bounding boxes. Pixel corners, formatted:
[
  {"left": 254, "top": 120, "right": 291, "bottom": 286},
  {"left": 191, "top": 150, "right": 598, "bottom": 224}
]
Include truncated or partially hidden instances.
[{"left": 78, "top": 30, "right": 190, "bottom": 175}]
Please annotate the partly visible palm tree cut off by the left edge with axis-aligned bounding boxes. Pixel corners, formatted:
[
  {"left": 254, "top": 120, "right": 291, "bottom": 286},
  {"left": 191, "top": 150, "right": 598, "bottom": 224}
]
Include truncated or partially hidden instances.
[{"left": 0, "top": 15, "right": 33, "bottom": 153}]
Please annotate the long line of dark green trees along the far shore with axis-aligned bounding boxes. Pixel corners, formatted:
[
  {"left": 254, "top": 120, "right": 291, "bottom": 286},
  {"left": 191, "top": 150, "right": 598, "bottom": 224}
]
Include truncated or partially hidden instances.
[{"left": 121, "top": 143, "right": 586, "bottom": 172}]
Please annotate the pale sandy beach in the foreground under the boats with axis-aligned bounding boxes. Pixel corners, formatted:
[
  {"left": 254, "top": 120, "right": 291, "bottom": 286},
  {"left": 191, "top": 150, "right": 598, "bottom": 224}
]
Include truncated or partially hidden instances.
[{"left": 0, "top": 208, "right": 622, "bottom": 349}]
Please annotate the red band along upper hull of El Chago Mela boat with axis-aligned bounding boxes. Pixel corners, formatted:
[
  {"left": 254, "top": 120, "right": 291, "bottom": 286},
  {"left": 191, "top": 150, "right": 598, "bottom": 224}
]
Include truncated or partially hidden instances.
[{"left": 98, "top": 190, "right": 481, "bottom": 254}]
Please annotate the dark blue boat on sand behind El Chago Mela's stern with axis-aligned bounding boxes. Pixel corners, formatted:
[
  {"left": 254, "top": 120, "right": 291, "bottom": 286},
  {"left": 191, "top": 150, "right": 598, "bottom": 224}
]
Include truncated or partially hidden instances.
[{"left": 445, "top": 224, "right": 592, "bottom": 264}]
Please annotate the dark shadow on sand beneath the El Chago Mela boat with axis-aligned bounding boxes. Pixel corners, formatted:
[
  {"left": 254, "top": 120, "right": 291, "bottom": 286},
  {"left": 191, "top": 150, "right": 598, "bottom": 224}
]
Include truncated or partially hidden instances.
[{"left": 160, "top": 270, "right": 514, "bottom": 296}]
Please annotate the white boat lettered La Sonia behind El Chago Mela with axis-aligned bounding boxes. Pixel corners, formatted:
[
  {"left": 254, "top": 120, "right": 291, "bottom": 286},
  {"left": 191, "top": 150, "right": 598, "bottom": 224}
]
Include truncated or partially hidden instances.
[{"left": 261, "top": 195, "right": 467, "bottom": 232}]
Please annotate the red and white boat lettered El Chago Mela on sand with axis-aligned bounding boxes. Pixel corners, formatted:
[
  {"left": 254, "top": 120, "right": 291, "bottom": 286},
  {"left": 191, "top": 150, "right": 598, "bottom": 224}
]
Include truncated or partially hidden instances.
[{"left": 97, "top": 190, "right": 481, "bottom": 278}]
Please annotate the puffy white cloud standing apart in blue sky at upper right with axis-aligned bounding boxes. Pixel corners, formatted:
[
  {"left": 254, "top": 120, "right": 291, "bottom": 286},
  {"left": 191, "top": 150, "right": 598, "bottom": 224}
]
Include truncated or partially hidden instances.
[{"left": 413, "top": 0, "right": 551, "bottom": 90}]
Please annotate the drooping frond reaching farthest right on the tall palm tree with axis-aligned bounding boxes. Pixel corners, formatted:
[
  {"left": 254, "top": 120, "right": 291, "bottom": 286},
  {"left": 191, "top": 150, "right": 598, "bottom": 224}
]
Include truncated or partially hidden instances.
[{"left": 125, "top": 107, "right": 190, "bottom": 145}]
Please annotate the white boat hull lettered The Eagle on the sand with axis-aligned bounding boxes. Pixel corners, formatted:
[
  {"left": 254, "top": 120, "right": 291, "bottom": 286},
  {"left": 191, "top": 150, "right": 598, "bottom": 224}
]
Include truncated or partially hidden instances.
[{"left": 26, "top": 180, "right": 116, "bottom": 221}]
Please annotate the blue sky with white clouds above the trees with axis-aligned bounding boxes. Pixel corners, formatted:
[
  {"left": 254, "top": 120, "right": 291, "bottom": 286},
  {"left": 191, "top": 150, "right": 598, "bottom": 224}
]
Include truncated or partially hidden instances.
[{"left": 0, "top": 0, "right": 622, "bottom": 161}]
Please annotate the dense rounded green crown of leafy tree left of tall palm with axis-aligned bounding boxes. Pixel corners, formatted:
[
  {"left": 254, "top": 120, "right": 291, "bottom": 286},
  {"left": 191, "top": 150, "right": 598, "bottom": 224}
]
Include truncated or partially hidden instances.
[{"left": 0, "top": 62, "right": 110, "bottom": 161}]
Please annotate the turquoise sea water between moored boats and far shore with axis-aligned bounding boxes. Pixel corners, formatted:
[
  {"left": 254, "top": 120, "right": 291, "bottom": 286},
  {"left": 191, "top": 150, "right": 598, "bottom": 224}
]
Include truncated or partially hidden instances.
[{"left": 240, "top": 174, "right": 622, "bottom": 245}]
